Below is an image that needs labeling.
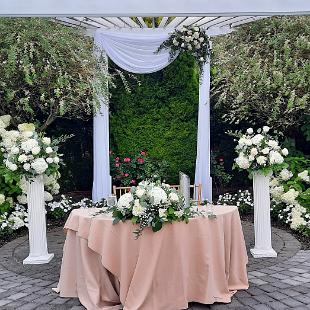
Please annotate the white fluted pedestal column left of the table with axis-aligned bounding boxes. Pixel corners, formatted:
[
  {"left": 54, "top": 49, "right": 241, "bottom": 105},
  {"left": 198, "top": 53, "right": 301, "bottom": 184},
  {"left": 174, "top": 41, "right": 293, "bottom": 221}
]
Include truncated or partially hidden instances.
[{"left": 23, "top": 176, "right": 54, "bottom": 264}]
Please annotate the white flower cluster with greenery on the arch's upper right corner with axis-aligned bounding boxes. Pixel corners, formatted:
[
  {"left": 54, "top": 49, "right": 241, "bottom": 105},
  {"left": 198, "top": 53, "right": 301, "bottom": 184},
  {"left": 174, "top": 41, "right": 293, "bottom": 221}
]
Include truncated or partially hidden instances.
[{"left": 157, "top": 26, "right": 211, "bottom": 70}]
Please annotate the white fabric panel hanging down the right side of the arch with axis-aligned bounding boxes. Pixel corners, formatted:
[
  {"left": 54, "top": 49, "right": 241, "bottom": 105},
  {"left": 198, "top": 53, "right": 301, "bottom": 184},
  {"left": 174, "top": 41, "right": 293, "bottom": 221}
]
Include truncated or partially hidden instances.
[{"left": 195, "top": 60, "right": 212, "bottom": 202}]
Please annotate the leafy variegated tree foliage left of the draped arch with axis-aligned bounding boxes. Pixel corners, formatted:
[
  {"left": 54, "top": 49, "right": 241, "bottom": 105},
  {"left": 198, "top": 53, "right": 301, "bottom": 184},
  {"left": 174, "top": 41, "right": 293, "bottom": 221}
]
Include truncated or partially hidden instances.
[{"left": 0, "top": 18, "right": 107, "bottom": 129}]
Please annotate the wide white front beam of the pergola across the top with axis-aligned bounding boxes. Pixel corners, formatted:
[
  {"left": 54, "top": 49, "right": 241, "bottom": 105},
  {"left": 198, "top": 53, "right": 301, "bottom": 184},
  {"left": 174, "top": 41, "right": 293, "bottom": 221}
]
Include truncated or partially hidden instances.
[{"left": 0, "top": 0, "right": 310, "bottom": 17}]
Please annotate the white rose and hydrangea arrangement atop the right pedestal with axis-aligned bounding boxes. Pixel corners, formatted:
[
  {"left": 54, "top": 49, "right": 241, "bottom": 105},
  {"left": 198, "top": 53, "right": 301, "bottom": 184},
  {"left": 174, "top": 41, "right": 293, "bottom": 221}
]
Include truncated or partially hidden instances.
[{"left": 235, "top": 126, "right": 288, "bottom": 174}]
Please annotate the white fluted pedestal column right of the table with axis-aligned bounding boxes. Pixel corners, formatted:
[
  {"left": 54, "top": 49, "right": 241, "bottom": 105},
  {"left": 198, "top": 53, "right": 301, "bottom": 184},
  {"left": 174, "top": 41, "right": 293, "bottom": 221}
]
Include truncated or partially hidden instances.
[{"left": 250, "top": 173, "right": 277, "bottom": 258}]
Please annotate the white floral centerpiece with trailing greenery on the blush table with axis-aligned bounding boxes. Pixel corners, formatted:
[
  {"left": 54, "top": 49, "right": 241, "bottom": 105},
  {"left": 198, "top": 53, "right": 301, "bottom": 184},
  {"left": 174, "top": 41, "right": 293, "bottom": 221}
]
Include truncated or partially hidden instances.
[{"left": 104, "top": 181, "right": 197, "bottom": 238}]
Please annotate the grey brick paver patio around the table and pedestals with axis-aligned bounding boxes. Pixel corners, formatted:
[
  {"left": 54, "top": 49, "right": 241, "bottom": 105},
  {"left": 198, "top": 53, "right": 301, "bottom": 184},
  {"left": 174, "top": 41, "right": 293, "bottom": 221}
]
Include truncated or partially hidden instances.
[{"left": 0, "top": 222, "right": 310, "bottom": 310}]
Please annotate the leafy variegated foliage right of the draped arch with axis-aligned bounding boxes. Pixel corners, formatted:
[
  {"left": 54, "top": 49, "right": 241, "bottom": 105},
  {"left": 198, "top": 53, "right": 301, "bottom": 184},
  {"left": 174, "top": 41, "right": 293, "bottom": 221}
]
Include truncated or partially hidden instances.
[{"left": 213, "top": 17, "right": 310, "bottom": 133}]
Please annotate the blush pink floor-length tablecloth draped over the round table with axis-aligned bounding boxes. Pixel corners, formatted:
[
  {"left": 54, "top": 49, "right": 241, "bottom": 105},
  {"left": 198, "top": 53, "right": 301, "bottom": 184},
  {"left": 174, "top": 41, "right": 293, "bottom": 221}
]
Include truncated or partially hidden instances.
[{"left": 58, "top": 206, "right": 248, "bottom": 310}]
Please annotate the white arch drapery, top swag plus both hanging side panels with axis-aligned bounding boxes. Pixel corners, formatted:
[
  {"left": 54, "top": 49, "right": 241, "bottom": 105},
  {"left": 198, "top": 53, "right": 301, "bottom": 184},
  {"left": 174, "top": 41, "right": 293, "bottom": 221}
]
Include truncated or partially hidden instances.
[{"left": 93, "top": 29, "right": 212, "bottom": 201}]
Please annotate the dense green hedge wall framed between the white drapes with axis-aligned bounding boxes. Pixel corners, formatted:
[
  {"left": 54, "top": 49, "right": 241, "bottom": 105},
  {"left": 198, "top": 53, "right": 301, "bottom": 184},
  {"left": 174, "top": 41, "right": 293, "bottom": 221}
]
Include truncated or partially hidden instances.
[{"left": 110, "top": 56, "right": 199, "bottom": 183}]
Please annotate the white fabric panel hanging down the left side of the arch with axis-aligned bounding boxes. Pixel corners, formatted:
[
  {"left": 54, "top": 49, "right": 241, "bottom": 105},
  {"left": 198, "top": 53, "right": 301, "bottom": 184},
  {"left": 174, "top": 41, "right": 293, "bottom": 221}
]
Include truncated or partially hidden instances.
[{"left": 92, "top": 46, "right": 111, "bottom": 201}]
